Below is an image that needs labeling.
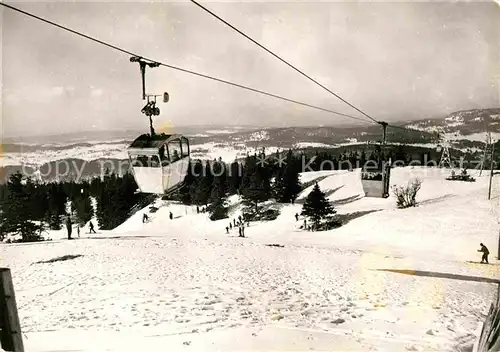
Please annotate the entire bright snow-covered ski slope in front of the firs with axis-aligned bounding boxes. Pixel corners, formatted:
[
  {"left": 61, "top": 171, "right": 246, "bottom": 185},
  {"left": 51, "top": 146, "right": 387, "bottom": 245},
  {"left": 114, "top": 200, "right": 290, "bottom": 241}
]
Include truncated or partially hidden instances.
[{"left": 0, "top": 168, "right": 500, "bottom": 352}]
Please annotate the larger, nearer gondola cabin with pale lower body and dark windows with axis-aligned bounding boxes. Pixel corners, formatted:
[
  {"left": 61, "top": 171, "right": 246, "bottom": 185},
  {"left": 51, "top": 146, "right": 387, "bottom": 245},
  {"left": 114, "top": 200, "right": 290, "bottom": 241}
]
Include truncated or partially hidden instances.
[{"left": 127, "top": 133, "right": 189, "bottom": 194}]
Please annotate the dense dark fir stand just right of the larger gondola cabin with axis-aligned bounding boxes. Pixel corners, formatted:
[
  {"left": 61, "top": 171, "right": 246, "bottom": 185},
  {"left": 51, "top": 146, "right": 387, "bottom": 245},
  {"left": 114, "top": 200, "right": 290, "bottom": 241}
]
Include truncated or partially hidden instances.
[{"left": 172, "top": 151, "right": 302, "bottom": 220}]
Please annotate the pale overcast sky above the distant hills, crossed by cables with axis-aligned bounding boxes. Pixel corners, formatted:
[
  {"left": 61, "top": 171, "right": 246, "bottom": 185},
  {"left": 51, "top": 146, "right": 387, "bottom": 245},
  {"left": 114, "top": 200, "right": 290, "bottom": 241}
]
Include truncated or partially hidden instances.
[{"left": 1, "top": 0, "right": 500, "bottom": 136}]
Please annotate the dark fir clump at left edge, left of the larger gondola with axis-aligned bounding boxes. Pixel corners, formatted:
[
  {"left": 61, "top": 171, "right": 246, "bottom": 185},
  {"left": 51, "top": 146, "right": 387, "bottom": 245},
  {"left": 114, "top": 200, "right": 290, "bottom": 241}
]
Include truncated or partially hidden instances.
[{"left": 0, "top": 172, "right": 152, "bottom": 242}]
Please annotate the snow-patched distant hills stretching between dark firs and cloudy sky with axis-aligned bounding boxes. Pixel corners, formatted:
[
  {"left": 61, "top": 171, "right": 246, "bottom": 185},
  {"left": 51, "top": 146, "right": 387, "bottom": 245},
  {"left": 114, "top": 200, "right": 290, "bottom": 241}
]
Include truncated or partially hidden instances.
[{"left": 0, "top": 108, "right": 500, "bottom": 182}]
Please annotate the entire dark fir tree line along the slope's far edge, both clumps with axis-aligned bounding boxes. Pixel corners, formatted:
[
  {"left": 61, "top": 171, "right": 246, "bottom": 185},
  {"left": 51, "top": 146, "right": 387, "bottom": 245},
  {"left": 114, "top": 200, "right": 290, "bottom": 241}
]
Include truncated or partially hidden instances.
[{"left": 0, "top": 147, "right": 450, "bottom": 241}]
